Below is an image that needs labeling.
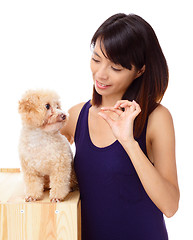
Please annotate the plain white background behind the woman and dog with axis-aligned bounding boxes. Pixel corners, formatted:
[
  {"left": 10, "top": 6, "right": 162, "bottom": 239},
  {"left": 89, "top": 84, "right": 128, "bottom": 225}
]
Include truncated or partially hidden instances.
[{"left": 0, "top": 0, "right": 193, "bottom": 240}]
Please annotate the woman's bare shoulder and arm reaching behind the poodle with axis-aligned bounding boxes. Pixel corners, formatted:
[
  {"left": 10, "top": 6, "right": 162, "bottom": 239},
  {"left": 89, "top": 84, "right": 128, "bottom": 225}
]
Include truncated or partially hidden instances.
[{"left": 60, "top": 102, "right": 85, "bottom": 144}]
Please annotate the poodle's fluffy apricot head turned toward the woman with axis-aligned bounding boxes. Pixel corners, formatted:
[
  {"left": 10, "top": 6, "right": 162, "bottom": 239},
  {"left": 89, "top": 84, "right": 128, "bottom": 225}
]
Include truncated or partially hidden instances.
[{"left": 19, "top": 90, "right": 67, "bottom": 131}]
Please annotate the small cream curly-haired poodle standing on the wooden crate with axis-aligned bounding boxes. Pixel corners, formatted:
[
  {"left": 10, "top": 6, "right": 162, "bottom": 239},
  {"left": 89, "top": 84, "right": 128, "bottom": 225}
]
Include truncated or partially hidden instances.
[{"left": 19, "top": 90, "right": 75, "bottom": 203}]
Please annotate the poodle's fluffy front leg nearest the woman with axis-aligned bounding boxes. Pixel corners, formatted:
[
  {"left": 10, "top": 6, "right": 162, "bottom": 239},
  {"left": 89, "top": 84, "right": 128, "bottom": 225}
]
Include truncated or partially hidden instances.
[{"left": 50, "top": 171, "right": 70, "bottom": 202}]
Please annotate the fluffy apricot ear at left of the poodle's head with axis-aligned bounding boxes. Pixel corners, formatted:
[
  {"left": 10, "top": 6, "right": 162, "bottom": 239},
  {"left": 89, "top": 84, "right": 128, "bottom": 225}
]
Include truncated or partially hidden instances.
[{"left": 18, "top": 95, "right": 39, "bottom": 113}]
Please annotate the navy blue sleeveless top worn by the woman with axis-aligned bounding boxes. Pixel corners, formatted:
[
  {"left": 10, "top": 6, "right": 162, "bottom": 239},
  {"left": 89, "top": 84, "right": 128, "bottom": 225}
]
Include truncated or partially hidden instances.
[{"left": 74, "top": 101, "right": 168, "bottom": 240}]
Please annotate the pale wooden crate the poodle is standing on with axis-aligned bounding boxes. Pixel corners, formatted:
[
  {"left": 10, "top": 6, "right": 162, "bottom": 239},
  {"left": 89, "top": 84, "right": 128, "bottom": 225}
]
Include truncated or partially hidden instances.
[{"left": 0, "top": 169, "right": 81, "bottom": 240}]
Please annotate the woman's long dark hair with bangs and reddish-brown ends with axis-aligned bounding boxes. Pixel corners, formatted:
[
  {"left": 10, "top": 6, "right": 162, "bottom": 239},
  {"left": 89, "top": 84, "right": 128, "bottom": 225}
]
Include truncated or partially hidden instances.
[{"left": 91, "top": 13, "right": 169, "bottom": 137}]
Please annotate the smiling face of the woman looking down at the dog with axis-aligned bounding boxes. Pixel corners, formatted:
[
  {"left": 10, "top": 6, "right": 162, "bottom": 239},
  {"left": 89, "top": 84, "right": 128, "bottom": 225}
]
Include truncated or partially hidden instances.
[{"left": 90, "top": 40, "right": 139, "bottom": 99}]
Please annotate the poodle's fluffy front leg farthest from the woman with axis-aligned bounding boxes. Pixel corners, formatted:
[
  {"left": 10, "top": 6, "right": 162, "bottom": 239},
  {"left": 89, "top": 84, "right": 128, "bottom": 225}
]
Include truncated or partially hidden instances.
[{"left": 24, "top": 174, "right": 44, "bottom": 202}]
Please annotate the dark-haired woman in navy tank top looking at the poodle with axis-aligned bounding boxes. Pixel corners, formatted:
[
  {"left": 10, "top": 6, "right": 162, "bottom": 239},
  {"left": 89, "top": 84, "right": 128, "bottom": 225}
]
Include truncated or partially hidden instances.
[{"left": 62, "top": 14, "right": 179, "bottom": 240}]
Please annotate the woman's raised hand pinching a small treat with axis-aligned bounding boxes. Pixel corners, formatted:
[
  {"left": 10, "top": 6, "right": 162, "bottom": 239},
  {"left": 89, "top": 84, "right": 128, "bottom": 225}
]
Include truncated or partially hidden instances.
[{"left": 98, "top": 100, "right": 141, "bottom": 143}]
